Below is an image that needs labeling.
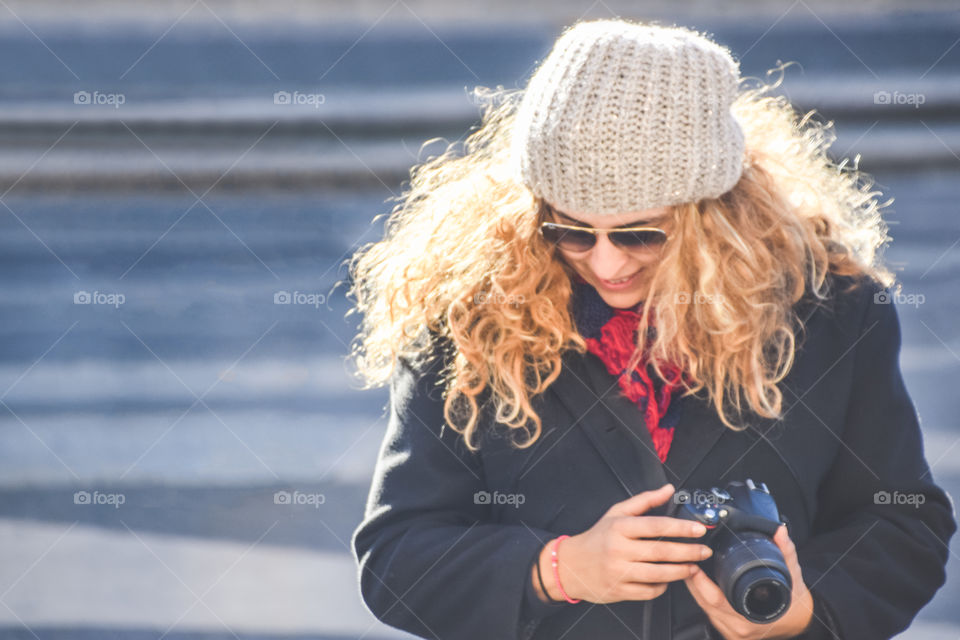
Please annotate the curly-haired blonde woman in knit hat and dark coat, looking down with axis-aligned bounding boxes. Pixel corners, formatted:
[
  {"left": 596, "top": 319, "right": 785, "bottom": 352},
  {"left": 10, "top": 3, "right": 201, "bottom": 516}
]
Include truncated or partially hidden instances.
[{"left": 351, "top": 20, "right": 956, "bottom": 640}]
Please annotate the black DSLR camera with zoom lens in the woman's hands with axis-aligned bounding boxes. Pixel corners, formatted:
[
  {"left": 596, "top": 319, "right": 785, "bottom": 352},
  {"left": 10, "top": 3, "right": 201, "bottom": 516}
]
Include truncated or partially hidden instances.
[{"left": 665, "top": 478, "right": 793, "bottom": 623}]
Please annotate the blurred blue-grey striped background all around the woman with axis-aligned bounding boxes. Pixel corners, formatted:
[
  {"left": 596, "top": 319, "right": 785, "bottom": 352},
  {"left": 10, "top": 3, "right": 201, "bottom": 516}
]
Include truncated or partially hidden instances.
[{"left": 0, "top": 0, "right": 960, "bottom": 640}]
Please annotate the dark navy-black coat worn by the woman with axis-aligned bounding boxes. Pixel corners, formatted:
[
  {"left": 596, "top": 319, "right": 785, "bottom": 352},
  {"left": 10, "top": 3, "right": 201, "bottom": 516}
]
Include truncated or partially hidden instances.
[{"left": 351, "top": 278, "right": 956, "bottom": 640}]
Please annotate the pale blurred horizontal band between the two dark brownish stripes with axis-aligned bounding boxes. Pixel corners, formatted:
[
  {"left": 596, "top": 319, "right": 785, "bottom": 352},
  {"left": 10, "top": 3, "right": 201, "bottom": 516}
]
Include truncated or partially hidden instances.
[{"left": 0, "top": 118, "right": 960, "bottom": 191}]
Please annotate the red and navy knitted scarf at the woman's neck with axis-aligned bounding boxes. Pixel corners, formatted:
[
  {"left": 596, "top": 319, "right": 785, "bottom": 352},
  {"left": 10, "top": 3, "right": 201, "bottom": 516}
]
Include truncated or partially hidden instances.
[{"left": 573, "top": 274, "right": 682, "bottom": 462}]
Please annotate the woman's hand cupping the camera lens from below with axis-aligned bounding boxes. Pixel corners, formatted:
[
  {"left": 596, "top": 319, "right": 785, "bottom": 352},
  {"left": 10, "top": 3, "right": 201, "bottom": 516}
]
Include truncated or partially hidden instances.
[{"left": 684, "top": 525, "right": 813, "bottom": 640}]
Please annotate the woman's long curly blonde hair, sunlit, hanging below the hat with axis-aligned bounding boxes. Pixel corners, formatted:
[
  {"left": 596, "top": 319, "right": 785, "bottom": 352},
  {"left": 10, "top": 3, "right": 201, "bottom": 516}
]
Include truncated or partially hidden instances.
[{"left": 347, "top": 65, "right": 894, "bottom": 451}]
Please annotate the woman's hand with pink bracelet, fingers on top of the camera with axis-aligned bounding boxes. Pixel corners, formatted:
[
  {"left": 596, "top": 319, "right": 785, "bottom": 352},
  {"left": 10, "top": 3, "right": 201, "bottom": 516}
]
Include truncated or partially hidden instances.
[{"left": 541, "top": 484, "right": 711, "bottom": 604}]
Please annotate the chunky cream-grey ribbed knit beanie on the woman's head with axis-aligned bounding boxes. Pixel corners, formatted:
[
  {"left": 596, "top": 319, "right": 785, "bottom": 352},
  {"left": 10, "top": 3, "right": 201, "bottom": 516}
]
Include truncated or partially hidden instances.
[{"left": 511, "top": 19, "right": 744, "bottom": 214}]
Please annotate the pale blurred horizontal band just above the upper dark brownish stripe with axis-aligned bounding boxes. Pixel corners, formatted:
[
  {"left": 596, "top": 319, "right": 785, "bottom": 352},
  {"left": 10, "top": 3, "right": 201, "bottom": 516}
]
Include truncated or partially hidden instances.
[{"left": 0, "top": 74, "right": 960, "bottom": 132}]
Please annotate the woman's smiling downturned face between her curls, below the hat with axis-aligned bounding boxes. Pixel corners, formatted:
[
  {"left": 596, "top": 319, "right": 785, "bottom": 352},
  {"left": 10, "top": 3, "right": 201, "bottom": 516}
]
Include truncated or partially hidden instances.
[{"left": 547, "top": 201, "right": 672, "bottom": 309}]
